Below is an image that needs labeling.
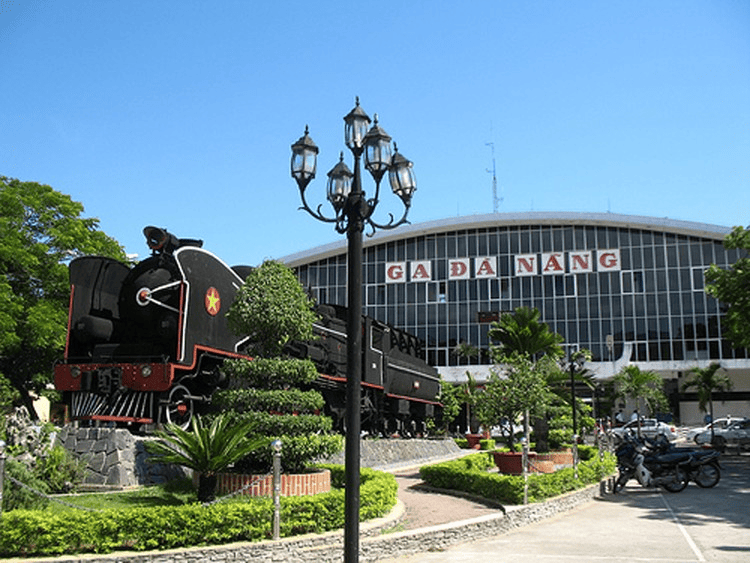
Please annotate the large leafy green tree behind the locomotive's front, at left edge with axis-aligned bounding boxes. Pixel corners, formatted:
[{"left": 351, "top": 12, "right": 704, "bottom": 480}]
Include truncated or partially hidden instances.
[{"left": 0, "top": 176, "right": 126, "bottom": 418}]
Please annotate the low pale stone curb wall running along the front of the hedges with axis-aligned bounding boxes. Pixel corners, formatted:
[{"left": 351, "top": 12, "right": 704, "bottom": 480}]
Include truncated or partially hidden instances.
[{"left": 23, "top": 478, "right": 613, "bottom": 563}]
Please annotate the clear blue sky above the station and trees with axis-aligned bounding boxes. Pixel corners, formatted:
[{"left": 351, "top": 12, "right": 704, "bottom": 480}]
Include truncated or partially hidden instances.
[{"left": 0, "top": 0, "right": 750, "bottom": 265}]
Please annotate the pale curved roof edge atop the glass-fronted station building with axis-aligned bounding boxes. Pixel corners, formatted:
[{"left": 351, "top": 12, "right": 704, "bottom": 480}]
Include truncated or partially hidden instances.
[{"left": 279, "top": 211, "right": 732, "bottom": 267}]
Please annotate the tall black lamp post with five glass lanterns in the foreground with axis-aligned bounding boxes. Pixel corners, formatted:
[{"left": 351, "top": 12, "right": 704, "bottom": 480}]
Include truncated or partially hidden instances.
[{"left": 291, "top": 98, "right": 416, "bottom": 563}]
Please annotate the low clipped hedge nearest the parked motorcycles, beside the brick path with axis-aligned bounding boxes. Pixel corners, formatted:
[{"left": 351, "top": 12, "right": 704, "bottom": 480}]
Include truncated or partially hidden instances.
[{"left": 419, "top": 448, "right": 616, "bottom": 504}]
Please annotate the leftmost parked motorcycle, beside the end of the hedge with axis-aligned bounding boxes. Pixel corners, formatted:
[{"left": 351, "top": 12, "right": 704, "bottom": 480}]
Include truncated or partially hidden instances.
[{"left": 614, "top": 434, "right": 692, "bottom": 493}]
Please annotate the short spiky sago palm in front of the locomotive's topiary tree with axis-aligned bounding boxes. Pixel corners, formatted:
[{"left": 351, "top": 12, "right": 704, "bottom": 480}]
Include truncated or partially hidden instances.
[{"left": 146, "top": 414, "right": 268, "bottom": 502}]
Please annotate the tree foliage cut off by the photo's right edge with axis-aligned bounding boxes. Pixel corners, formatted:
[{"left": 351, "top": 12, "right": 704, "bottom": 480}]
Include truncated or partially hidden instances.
[{"left": 706, "top": 227, "right": 750, "bottom": 348}]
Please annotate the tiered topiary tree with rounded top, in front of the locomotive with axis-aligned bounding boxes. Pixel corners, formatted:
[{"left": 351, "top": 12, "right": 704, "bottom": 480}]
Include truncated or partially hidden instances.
[{"left": 212, "top": 261, "right": 342, "bottom": 473}]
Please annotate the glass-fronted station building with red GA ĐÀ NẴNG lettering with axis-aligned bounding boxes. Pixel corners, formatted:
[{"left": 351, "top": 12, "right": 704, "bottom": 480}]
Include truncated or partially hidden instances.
[{"left": 281, "top": 212, "right": 750, "bottom": 424}]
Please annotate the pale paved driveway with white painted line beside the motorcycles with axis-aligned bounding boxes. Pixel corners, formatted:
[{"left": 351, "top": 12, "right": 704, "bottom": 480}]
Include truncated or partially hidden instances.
[{"left": 382, "top": 455, "right": 750, "bottom": 563}]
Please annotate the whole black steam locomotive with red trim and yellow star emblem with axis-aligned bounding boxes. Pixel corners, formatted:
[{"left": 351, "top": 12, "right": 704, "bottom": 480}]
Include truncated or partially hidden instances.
[{"left": 55, "top": 227, "right": 440, "bottom": 435}]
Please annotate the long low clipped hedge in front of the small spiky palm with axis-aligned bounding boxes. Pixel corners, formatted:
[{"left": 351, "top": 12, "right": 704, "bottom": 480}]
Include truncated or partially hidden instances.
[{"left": 0, "top": 465, "right": 398, "bottom": 557}]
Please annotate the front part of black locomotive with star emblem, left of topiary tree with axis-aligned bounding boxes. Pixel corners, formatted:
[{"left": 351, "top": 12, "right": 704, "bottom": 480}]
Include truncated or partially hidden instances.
[{"left": 55, "top": 227, "right": 253, "bottom": 426}]
